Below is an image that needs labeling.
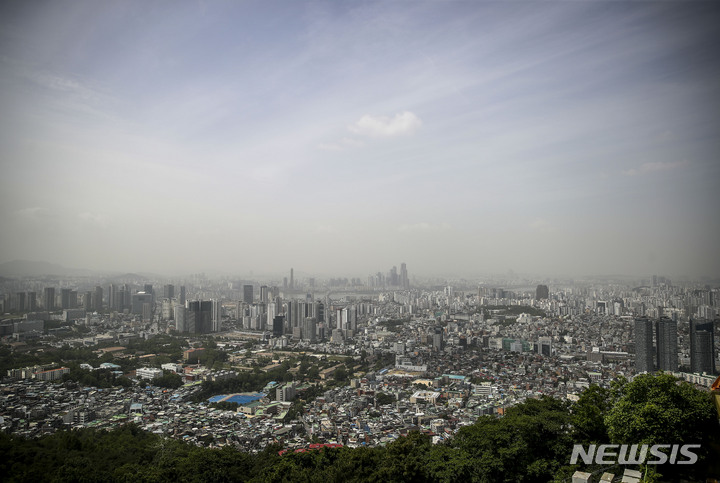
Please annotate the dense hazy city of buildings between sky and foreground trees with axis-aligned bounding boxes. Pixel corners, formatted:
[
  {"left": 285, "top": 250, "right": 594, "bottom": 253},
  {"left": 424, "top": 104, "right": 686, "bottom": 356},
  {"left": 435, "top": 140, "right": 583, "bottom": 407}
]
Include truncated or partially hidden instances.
[{"left": 0, "top": 263, "right": 720, "bottom": 480}]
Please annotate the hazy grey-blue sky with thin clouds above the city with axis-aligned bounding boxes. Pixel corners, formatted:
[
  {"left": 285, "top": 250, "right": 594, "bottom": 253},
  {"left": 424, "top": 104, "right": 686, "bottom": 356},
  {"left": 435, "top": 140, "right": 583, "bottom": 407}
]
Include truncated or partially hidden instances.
[{"left": 0, "top": 0, "right": 720, "bottom": 277}]
